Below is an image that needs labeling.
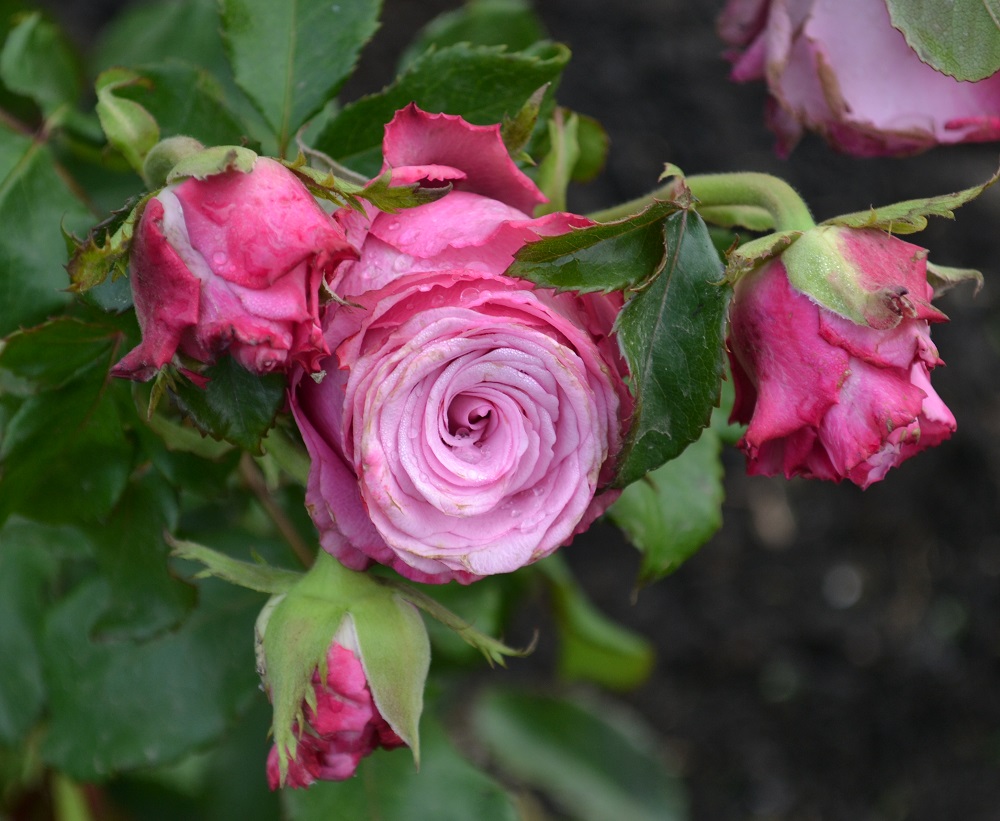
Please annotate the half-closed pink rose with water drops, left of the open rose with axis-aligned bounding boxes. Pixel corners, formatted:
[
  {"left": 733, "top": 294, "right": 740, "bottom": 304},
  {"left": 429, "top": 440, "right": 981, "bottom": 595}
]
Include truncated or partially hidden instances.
[{"left": 112, "top": 157, "right": 354, "bottom": 380}]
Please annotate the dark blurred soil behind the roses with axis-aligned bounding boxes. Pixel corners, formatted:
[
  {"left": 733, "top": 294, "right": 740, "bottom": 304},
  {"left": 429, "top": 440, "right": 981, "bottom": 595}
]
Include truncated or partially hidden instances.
[{"left": 39, "top": 0, "right": 1000, "bottom": 821}]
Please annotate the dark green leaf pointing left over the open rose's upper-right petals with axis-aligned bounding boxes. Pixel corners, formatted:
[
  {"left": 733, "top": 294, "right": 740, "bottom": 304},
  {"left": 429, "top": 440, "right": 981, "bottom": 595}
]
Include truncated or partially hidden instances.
[{"left": 507, "top": 202, "right": 680, "bottom": 293}]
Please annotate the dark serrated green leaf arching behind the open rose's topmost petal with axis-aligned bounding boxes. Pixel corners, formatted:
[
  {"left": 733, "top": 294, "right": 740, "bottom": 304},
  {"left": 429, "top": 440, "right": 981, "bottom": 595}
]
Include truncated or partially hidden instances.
[{"left": 315, "top": 44, "right": 569, "bottom": 177}]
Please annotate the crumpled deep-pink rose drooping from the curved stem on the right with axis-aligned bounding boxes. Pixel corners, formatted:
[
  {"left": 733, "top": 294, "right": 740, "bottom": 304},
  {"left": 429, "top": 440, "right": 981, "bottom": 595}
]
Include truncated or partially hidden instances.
[{"left": 728, "top": 227, "right": 955, "bottom": 488}]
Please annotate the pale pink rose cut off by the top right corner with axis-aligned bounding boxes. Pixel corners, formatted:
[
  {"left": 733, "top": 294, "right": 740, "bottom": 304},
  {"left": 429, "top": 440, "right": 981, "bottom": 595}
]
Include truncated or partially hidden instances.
[{"left": 719, "top": 0, "right": 1000, "bottom": 157}]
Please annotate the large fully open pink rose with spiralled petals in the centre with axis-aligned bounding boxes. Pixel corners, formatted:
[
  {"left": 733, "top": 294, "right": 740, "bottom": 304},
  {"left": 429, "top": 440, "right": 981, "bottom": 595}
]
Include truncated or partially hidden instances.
[{"left": 291, "top": 106, "right": 631, "bottom": 583}]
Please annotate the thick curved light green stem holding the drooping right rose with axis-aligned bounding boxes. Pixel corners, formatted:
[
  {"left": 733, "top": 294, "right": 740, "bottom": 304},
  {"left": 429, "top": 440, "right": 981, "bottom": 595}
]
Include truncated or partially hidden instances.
[{"left": 590, "top": 171, "right": 816, "bottom": 231}]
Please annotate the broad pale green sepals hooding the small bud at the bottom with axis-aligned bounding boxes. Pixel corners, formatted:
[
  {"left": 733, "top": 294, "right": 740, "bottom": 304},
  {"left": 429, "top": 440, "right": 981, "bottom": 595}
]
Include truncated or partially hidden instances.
[{"left": 263, "top": 551, "right": 430, "bottom": 779}]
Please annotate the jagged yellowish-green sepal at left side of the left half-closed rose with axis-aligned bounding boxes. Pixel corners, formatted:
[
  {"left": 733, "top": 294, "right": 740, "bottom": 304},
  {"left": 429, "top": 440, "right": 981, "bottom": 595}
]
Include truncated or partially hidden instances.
[{"left": 63, "top": 194, "right": 153, "bottom": 294}]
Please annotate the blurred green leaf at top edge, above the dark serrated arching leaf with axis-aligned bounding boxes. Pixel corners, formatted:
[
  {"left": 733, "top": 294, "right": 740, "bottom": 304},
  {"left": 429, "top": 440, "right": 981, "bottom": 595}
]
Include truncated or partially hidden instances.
[{"left": 399, "top": 0, "right": 547, "bottom": 71}]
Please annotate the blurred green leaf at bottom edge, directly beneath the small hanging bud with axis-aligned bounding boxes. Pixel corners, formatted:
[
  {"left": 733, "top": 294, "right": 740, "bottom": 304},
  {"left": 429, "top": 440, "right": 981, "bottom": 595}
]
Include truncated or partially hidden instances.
[{"left": 281, "top": 715, "right": 520, "bottom": 821}]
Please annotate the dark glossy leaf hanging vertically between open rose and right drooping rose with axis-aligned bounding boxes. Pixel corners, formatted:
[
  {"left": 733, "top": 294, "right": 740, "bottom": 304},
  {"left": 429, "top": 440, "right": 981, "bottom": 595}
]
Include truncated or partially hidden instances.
[{"left": 616, "top": 211, "right": 730, "bottom": 487}]
